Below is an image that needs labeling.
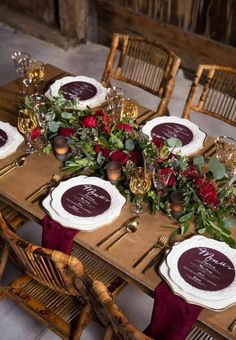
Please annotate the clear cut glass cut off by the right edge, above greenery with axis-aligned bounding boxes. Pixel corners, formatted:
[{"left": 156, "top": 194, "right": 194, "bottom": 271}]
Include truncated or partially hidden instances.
[{"left": 215, "top": 136, "right": 236, "bottom": 178}]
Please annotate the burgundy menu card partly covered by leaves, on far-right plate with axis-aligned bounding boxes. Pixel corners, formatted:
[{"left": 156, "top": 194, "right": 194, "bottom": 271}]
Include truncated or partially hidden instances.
[{"left": 151, "top": 123, "right": 193, "bottom": 145}]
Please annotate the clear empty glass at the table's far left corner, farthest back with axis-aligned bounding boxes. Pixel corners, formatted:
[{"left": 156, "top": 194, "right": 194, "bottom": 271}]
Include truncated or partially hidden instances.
[{"left": 11, "top": 51, "right": 30, "bottom": 95}]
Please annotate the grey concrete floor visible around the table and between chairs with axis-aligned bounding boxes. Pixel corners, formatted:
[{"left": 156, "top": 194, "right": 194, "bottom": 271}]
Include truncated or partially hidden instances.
[{"left": 0, "top": 23, "right": 236, "bottom": 340}]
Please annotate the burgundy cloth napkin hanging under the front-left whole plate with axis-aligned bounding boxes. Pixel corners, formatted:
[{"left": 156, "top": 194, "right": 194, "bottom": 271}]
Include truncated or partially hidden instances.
[{"left": 42, "top": 215, "right": 79, "bottom": 255}]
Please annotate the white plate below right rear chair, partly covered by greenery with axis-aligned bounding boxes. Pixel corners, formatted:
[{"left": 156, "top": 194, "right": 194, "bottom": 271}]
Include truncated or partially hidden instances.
[{"left": 142, "top": 116, "right": 206, "bottom": 156}]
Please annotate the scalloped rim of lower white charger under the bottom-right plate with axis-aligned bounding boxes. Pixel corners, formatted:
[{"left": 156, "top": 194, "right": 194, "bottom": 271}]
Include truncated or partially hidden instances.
[{"left": 159, "top": 260, "right": 236, "bottom": 312}]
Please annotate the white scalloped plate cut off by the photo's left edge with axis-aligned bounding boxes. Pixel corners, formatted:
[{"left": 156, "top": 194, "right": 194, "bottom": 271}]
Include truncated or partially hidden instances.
[{"left": 0, "top": 122, "right": 24, "bottom": 159}]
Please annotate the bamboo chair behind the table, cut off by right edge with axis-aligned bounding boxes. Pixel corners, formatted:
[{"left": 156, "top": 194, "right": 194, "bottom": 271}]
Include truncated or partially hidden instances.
[{"left": 182, "top": 65, "right": 236, "bottom": 126}]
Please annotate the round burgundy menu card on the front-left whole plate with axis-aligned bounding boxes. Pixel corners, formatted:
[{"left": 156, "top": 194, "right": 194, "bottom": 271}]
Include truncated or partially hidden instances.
[{"left": 61, "top": 184, "right": 111, "bottom": 217}]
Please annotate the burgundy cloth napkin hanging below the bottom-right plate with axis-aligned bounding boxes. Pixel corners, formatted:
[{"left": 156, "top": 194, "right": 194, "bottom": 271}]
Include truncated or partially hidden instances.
[{"left": 145, "top": 281, "right": 203, "bottom": 340}]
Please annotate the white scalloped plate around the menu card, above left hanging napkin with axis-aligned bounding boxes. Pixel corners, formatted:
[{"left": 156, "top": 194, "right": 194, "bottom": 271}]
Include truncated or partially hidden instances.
[{"left": 43, "top": 176, "right": 126, "bottom": 231}]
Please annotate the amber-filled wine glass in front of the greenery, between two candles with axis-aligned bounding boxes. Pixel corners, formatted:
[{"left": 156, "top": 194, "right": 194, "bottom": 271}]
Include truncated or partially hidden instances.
[{"left": 129, "top": 168, "right": 152, "bottom": 215}]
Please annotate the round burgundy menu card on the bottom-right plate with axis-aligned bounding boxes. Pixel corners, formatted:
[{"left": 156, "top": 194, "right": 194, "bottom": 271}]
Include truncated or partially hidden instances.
[{"left": 177, "top": 247, "right": 235, "bottom": 291}]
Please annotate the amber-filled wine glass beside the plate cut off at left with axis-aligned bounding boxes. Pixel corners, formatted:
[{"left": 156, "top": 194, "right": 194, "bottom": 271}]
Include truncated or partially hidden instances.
[{"left": 18, "top": 109, "right": 38, "bottom": 154}]
